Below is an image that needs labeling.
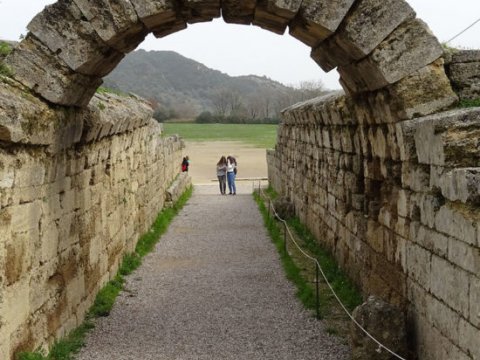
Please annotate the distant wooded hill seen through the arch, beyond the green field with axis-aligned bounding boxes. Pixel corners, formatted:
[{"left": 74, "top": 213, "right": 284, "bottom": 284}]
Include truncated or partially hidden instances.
[{"left": 104, "top": 50, "right": 321, "bottom": 118}]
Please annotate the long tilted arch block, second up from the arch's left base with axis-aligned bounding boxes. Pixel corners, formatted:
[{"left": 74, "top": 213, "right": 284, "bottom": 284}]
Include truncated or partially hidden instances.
[{"left": 27, "top": 0, "right": 124, "bottom": 77}]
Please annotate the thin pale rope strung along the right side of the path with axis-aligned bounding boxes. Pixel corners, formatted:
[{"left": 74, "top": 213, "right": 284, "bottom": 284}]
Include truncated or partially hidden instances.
[{"left": 258, "top": 183, "right": 404, "bottom": 360}]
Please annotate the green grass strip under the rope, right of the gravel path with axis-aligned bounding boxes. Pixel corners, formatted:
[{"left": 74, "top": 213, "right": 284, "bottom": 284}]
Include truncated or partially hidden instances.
[{"left": 255, "top": 188, "right": 362, "bottom": 324}]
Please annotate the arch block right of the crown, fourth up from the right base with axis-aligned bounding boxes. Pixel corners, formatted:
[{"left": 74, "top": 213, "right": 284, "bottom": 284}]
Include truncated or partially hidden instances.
[{"left": 290, "top": 0, "right": 354, "bottom": 47}]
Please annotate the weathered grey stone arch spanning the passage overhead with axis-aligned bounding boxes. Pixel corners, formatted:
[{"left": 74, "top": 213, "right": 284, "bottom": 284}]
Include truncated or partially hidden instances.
[{"left": 6, "top": 0, "right": 452, "bottom": 115}]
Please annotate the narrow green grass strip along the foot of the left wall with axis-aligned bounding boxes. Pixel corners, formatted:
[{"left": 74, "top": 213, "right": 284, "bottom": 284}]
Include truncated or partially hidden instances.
[{"left": 16, "top": 187, "right": 193, "bottom": 360}]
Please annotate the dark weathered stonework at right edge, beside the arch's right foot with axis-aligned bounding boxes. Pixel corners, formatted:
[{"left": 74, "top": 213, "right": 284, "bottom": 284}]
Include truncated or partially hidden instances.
[{"left": 446, "top": 50, "right": 480, "bottom": 100}]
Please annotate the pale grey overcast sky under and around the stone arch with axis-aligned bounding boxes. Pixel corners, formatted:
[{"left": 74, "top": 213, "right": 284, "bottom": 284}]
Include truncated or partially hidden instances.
[{"left": 0, "top": 0, "right": 480, "bottom": 89}]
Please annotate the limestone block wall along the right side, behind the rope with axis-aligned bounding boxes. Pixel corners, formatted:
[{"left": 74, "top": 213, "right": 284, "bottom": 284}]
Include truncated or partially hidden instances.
[{"left": 267, "top": 93, "right": 480, "bottom": 360}]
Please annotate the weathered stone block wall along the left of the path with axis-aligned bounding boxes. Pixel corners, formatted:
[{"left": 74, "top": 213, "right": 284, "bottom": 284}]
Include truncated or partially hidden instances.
[{"left": 0, "top": 78, "right": 185, "bottom": 359}]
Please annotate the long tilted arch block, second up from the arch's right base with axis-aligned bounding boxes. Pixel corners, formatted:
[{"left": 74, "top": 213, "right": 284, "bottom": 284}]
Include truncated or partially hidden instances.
[{"left": 338, "top": 19, "right": 443, "bottom": 92}]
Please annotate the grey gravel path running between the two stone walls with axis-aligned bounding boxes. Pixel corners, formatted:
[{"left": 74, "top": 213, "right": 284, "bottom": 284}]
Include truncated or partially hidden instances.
[{"left": 77, "top": 186, "right": 349, "bottom": 360}]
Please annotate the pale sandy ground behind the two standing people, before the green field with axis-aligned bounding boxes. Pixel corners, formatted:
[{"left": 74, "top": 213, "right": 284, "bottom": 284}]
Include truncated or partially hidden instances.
[{"left": 183, "top": 141, "right": 268, "bottom": 185}]
